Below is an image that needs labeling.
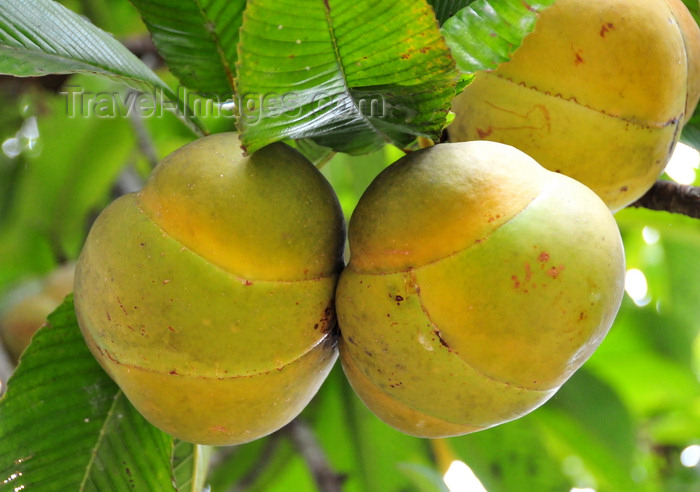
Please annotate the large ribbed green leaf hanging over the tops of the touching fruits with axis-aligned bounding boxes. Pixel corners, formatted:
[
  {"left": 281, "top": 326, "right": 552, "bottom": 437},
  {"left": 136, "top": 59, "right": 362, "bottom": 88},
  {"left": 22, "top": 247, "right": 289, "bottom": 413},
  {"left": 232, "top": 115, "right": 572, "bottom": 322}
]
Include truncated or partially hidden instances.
[{"left": 236, "top": 0, "right": 458, "bottom": 154}]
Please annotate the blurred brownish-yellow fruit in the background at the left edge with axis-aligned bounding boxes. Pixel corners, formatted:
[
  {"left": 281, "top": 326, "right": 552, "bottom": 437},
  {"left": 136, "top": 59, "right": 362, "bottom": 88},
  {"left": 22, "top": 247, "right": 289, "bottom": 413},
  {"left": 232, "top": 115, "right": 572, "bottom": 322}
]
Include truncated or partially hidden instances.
[{"left": 0, "top": 262, "right": 75, "bottom": 362}]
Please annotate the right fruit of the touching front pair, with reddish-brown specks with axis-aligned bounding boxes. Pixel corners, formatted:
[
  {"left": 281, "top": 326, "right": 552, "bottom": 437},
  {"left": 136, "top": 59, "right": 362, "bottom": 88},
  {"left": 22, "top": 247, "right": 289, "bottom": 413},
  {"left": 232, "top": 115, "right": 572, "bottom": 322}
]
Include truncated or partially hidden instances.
[{"left": 336, "top": 141, "right": 625, "bottom": 437}]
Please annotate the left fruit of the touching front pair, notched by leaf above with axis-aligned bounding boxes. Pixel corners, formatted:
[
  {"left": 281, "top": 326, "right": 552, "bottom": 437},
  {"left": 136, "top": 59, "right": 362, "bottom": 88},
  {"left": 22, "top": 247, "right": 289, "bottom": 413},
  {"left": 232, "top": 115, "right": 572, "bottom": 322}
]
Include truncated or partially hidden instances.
[{"left": 75, "top": 133, "right": 345, "bottom": 445}]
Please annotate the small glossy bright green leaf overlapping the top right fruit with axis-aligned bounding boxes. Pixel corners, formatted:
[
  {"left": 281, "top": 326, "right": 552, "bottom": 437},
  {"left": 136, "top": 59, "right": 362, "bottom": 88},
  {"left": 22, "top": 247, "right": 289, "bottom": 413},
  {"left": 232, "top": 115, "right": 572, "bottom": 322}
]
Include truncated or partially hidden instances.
[{"left": 442, "top": 0, "right": 554, "bottom": 73}]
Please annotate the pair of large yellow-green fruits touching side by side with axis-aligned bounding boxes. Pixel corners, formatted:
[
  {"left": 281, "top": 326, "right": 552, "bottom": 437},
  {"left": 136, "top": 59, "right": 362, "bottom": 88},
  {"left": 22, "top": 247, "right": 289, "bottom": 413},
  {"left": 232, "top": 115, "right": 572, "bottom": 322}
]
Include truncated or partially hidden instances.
[{"left": 75, "top": 133, "right": 624, "bottom": 445}]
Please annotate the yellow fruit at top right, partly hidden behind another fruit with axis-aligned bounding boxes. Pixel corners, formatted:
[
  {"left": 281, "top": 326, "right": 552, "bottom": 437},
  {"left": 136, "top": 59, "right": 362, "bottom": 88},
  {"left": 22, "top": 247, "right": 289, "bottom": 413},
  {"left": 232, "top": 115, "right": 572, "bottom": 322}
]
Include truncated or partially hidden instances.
[{"left": 448, "top": 0, "right": 700, "bottom": 211}]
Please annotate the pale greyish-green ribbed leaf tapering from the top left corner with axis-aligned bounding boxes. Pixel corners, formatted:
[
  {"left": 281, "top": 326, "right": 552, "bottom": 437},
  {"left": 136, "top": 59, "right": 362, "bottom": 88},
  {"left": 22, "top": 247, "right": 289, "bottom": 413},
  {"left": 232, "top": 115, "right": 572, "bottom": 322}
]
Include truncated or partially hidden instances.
[{"left": 0, "top": 0, "right": 166, "bottom": 89}]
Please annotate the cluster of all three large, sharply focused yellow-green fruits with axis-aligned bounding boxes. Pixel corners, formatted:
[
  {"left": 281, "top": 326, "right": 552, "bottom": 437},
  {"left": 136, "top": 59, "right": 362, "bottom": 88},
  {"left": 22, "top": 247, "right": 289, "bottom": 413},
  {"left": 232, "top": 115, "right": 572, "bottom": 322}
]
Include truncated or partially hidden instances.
[{"left": 4, "top": 0, "right": 700, "bottom": 445}]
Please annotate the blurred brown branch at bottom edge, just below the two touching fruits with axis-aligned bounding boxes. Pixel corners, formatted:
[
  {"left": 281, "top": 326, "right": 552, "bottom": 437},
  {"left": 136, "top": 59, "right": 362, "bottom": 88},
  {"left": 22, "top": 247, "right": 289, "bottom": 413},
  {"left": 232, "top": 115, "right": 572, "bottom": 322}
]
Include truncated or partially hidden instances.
[{"left": 285, "top": 418, "right": 345, "bottom": 492}]
